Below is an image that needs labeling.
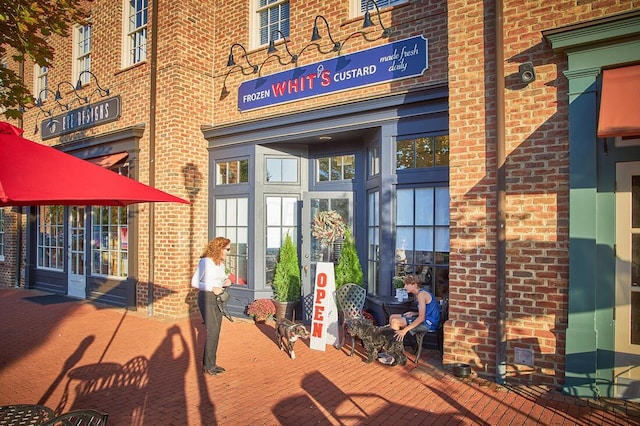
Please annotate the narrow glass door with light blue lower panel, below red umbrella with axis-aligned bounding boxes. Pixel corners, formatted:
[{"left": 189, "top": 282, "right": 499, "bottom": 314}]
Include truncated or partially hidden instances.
[{"left": 67, "top": 206, "right": 87, "bottom": 299}]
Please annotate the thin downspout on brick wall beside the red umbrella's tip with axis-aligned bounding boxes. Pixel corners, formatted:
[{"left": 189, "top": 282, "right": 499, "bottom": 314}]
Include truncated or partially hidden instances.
[{"left": 147, "top": 0, "right": 158, "bottom": 315}]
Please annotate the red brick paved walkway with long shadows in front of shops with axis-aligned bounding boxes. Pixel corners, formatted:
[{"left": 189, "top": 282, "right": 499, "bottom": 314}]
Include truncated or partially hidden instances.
[{"left": 0, "top": 289, "right": 640, "bottom": 426}]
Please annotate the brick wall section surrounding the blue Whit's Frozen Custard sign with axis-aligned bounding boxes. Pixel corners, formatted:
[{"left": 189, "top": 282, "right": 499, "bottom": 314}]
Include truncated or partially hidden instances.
[{"left": 212, "top": 0, "right": 447, "bottom": 125}]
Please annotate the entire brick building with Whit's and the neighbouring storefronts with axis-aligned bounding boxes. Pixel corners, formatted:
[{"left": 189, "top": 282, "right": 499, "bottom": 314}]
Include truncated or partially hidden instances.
[{"left": 0, "top": 0, "right": 640, "bottom": 398}]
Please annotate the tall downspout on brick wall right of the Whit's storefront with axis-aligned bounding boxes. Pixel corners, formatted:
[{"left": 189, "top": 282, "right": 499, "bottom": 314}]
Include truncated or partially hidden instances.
[{"left": 495, "top": 0, "right": 507, "bottom": 384}]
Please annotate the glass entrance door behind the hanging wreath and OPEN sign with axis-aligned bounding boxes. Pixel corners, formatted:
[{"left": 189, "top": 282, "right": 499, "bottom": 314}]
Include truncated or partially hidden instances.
[{"left": 300, "top": 192, "right": 354, "bottom": 296}]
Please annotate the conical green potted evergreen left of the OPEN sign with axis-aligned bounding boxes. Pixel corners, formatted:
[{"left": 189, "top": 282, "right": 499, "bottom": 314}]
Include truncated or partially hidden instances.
[{"left": 271, "top": 234, "right": 301, "bottom": 319}]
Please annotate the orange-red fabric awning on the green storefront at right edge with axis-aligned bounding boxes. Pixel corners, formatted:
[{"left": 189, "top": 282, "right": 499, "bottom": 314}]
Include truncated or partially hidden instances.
[{"left": 598, "top": 65, "right": 640, "bottom": 138}]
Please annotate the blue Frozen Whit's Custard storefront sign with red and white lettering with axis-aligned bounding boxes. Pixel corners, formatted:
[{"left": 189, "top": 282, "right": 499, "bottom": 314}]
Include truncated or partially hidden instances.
[{"left": 238, "top": 36, "right": 429, "bottom": 111}]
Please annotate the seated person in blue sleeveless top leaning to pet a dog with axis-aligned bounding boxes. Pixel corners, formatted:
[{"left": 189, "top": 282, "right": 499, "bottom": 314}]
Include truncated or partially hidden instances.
[{"left": 389, "top": 275, "right": 440, "bottom": 340}]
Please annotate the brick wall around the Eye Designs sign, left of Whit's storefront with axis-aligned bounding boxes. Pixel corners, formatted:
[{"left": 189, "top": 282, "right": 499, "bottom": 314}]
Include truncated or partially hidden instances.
[{"left": 0, "top": 0, "right": 217, "bottom": 316}]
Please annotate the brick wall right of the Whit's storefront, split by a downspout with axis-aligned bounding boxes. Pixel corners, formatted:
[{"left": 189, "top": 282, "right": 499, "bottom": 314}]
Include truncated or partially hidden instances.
[{"left": 444, "top": 0, "right": 637, "bottom": 385}]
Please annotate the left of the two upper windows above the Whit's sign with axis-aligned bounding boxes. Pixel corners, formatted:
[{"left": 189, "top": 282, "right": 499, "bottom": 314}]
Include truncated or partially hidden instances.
[{"left": 252, "top": 0, "right": 289, "bottom": 48}]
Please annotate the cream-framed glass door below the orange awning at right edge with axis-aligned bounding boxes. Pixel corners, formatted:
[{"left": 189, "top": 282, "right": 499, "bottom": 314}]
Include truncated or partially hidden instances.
[{"left": 614, "top": 162, "right": 640, "bottom": 400}]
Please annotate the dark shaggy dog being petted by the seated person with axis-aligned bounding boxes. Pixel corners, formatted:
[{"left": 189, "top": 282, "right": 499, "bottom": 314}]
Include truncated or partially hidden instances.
[{"left": 347, "top": 318, "right": 407, "bottom": 365}]
